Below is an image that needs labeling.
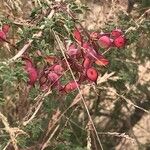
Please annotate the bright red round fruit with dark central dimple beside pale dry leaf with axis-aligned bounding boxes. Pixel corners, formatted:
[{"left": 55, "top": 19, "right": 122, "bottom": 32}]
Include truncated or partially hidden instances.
[{"left": 86, "top": 68, "right": 98, "bottom": 83}]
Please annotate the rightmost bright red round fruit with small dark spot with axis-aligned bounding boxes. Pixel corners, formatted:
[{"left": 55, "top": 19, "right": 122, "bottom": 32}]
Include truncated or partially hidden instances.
[{"left": 114, "top": 36, "right": 126, "bottom": 48}]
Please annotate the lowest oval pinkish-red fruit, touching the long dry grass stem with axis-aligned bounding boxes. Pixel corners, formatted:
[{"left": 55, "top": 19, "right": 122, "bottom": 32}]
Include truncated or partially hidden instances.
[{"left": 64, "top": 81, "right": 79, "bottom": 93}]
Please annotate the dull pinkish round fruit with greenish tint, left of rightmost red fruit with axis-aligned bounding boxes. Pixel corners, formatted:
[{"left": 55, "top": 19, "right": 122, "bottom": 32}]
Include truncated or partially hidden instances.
[{"left": 99, "top": 36, "right": 112, "bottom": 48}]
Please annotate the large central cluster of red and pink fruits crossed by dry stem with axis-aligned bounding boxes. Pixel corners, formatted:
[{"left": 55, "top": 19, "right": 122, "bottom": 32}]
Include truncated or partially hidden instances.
[{"left": 23, "top": 28, "right": 126, "bottom": 93}]
